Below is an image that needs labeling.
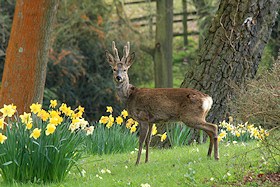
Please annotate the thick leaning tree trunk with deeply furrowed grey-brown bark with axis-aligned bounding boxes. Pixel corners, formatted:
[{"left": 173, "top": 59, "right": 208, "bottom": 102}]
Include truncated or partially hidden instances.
[{"left": 181, "top": 0, "right": 280, "bottom": 123}]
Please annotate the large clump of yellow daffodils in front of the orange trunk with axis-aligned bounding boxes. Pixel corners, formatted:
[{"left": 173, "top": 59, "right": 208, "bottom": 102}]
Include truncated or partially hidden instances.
[{"left": 0, "top": 101, "right": 93, "bottom": 182}]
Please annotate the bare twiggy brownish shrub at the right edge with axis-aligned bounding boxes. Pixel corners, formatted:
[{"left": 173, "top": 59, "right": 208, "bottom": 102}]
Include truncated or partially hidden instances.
[{"left": 231, "top": 63, "right": 280, "bottom": 128}]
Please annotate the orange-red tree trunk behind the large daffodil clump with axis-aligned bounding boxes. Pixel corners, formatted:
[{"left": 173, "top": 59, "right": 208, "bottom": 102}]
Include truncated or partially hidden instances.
[{"left": 0, "top": 0, "right": 58, "bottom": 113}]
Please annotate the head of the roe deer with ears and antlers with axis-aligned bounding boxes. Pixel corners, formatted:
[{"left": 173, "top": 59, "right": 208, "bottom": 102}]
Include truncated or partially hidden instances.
[{"left": 106, "top": 41, "right": 135, "bottom": 84}]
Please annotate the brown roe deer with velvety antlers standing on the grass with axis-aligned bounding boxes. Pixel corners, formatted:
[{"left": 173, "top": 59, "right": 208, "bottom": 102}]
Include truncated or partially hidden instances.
[{"left": 106, "top": 41, "right": 219, "bottom": 165}]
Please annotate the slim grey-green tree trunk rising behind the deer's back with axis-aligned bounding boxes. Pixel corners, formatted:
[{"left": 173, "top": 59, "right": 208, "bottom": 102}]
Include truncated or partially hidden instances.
[{"left": 154, "top": 0, "right": 173, "bottom": 88}]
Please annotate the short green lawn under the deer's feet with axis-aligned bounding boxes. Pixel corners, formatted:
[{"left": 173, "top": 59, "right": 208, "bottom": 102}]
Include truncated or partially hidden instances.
[{"left": 1, "top": 141, "right": 272, "bottom": 186}]
